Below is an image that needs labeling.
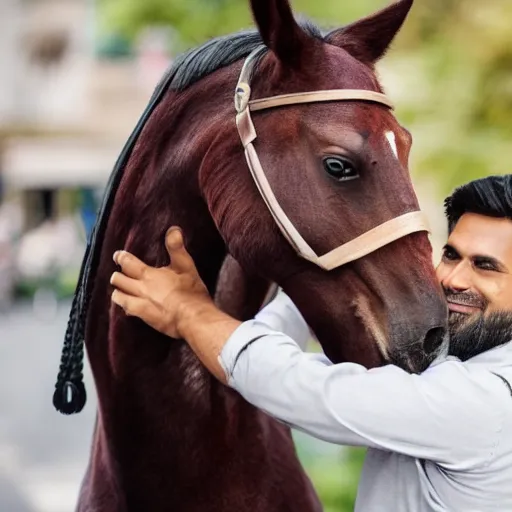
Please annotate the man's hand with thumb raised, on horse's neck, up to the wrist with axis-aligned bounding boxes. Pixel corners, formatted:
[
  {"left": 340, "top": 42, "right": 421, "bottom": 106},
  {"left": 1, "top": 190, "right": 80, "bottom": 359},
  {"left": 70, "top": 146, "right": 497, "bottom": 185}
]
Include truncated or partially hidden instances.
[{"left": 110, "top": 228, "right": 213, "bottom": 338}]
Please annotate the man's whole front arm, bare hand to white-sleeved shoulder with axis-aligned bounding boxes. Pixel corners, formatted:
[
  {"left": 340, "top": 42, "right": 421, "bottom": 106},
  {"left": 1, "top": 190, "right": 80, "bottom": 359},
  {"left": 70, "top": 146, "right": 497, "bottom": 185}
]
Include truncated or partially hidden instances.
[{"left": 112, "top": 230, "right": 502, "bottom": 469}]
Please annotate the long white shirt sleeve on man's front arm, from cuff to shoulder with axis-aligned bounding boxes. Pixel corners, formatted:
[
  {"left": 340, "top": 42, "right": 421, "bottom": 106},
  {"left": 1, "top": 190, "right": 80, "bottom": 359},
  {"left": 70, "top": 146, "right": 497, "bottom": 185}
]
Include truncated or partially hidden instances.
[{"left": 220, "top": 320, "right": 501, "bottom": 469}]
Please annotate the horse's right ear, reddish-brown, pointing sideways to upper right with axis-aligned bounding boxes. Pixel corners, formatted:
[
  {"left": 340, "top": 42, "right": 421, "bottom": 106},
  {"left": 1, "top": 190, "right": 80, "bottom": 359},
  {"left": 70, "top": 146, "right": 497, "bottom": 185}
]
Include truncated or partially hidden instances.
[{"left": 326, "top": 0, "right": 414, "bottom": 66}]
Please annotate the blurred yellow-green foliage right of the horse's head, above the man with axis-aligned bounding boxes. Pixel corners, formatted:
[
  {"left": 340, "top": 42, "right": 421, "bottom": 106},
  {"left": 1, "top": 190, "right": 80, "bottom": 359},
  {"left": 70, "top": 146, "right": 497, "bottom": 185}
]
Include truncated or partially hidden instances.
[{"left": 383, "top": 0, "right": 512, "bottom": 195}]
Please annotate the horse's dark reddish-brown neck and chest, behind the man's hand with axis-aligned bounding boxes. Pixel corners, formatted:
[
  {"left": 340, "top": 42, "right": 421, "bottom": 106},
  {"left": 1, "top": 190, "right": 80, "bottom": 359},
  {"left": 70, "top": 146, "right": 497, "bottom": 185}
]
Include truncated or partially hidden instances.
[{"left": 79, "top": 70, "right": 317, "bottom": 510}]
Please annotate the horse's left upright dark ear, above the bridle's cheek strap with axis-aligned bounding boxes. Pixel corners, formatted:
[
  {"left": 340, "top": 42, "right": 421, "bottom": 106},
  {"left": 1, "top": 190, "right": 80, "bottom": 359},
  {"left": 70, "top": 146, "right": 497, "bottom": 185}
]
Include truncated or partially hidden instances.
[{"left": 251, "top": 0, "right": 308, "bottom": 65}]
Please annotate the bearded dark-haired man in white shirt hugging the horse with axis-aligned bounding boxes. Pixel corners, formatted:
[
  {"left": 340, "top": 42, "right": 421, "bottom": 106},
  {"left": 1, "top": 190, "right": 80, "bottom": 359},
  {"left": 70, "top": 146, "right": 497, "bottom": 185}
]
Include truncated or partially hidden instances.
[{"left": 112, "top": 175, "right": 512, "bottom": 512}]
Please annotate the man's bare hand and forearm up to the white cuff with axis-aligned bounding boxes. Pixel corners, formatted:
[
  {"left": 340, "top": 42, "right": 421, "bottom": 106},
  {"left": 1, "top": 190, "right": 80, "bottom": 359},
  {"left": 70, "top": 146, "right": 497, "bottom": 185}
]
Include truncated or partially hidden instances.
[{"left": 110, "top": 228, "right": 241, "bottom": 383}]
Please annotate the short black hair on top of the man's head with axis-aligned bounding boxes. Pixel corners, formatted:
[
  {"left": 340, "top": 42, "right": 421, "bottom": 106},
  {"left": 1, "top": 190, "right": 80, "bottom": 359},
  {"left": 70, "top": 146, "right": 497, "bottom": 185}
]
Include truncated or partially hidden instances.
[{"left": 444, "top": 174, "right": 512, "bottom": 233}]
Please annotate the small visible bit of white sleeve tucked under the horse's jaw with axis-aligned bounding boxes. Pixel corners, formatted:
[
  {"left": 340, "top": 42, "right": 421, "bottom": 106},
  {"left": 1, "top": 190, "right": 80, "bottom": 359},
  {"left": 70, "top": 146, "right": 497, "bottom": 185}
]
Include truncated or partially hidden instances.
[{"left": 256, "top": 288, "right": 313, "bottom": 350}]
